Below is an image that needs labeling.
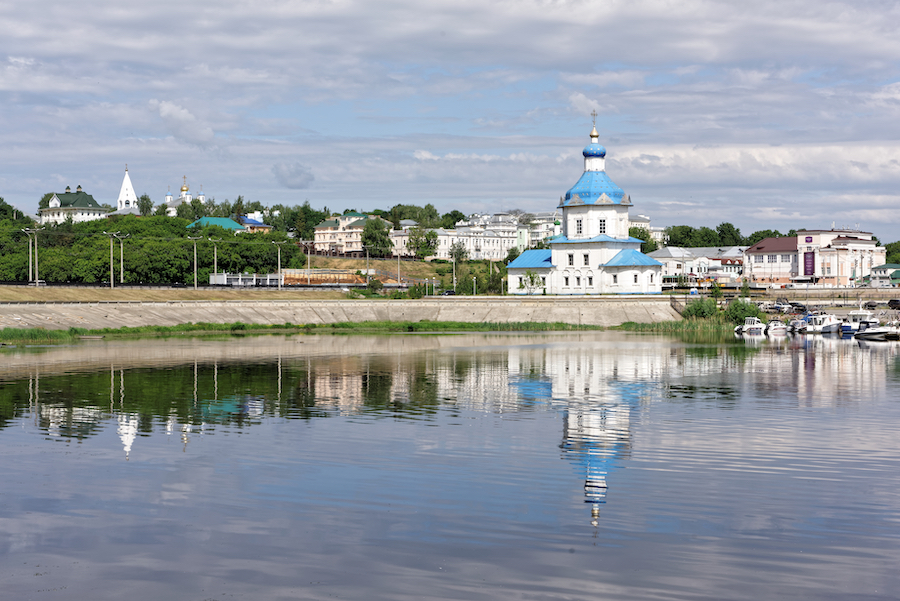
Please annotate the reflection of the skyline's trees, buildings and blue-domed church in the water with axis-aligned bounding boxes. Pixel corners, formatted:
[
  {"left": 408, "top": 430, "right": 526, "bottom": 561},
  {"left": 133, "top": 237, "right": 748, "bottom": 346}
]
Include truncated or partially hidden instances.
[{"left": 0, "top": 333, "right": 900, "bottom": 524}]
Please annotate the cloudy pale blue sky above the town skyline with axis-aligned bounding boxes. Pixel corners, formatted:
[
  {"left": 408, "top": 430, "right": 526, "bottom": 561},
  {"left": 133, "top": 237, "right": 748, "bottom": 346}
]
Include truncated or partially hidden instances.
[{"left": 0, "top": 0, "right": 900, "bottom": 242}]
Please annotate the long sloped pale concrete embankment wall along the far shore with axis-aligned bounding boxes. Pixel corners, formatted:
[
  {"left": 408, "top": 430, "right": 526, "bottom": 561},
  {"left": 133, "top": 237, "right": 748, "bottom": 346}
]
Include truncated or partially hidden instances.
[{"left": 0, "top": 296, "right": 680, "bottom": 329}]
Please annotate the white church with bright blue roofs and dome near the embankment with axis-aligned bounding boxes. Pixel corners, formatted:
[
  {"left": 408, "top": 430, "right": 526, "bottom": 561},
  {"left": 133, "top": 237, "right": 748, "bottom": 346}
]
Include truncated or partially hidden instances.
[{"left": 507, "top": 125, "right": 663, "bottom": 294}]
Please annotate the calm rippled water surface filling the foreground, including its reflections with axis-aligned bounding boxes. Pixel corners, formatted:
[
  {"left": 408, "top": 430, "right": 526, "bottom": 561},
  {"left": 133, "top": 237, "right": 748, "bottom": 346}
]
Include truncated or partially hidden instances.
[{"left": 0, "top": 332, "right": 900, "bottom": 600}]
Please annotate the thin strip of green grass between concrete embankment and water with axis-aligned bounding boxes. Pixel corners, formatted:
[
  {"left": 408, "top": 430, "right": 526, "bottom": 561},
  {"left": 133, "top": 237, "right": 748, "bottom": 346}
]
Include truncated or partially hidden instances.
[{"left": 0, "top": 321, "right": 603, "bottom": 344}]
